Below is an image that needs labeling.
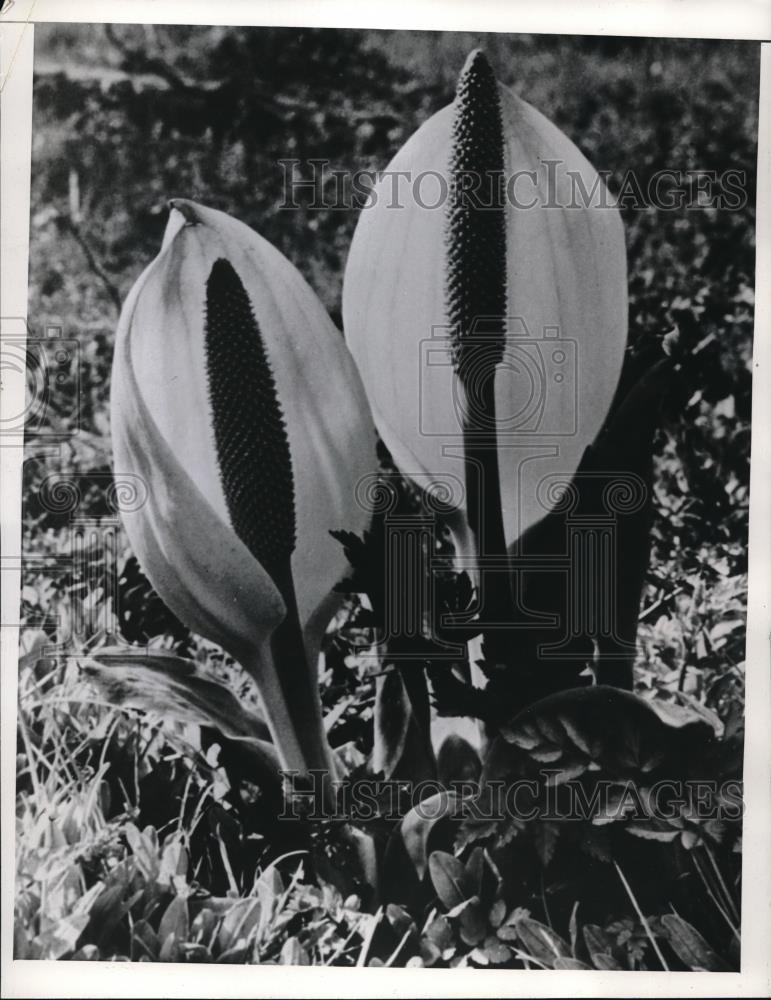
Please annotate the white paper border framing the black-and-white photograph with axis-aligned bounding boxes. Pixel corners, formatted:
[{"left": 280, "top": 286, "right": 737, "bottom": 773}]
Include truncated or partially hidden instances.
[{"left": 0, "top": 0, "right": 771, "bottom": 998}]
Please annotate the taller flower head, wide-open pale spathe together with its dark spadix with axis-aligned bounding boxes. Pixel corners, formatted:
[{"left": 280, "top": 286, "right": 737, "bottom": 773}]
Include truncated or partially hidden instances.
[{"left": 343, "top": 51, "right": 627, "bottom": 555}]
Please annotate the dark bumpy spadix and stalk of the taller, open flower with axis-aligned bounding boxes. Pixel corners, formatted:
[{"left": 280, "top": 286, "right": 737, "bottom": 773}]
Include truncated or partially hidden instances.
[{"left": 445, "top": 49, "right": 511, "bottom": 640}]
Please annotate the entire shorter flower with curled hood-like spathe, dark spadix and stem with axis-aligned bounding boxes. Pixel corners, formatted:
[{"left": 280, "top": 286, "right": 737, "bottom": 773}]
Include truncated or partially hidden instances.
[{"left": 111, "top": 201, "right": 375, "bottom": 773}]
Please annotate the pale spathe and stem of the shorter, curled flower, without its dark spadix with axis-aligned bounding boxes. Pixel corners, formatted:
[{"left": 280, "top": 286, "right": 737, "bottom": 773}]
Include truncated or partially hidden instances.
[{"left": 111, "top": 201, "right": 376, "bottom": 770}]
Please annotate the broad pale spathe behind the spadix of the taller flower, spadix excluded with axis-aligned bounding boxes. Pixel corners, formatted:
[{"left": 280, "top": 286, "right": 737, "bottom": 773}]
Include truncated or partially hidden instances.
[{"left": 343, "top": 81, "right": 627, "bottom": 544}]
